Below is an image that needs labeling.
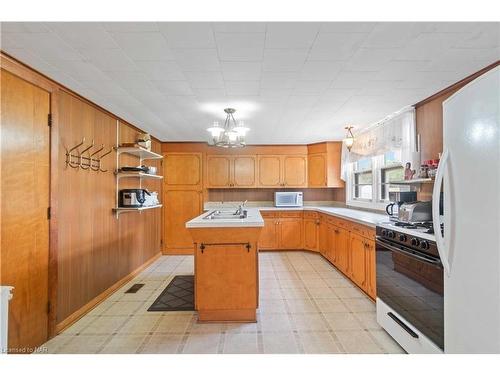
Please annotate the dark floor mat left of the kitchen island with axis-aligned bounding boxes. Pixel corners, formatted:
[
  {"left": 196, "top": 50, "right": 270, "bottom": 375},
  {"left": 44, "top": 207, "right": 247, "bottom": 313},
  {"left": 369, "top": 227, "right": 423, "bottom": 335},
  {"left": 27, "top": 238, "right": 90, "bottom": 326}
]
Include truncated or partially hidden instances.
[{"left": 148, "top": 275, "right": 194, "bottom": 311}]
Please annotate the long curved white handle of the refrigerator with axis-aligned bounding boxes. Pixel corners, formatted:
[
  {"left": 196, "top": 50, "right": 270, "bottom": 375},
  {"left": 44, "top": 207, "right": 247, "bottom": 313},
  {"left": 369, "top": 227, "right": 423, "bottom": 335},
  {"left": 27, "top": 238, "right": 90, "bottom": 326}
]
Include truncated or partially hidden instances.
[{"left": 432, "top": 150, "right": 451, "bottom": 276}]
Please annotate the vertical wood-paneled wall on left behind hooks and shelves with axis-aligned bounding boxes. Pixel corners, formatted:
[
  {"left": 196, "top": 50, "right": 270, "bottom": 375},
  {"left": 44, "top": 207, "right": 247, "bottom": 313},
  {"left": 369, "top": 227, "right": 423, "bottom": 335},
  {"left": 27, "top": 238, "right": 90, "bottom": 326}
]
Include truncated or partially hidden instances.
[{"left": 57, "top": 92, "right": 161, "bottom": 326}]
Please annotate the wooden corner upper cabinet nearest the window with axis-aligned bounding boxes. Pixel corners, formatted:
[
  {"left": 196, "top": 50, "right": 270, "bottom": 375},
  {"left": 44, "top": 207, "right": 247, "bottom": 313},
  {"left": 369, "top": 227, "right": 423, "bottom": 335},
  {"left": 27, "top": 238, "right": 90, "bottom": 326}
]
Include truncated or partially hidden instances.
[{"left": 307, "top": 142, "right": 344, "bottom": 187}]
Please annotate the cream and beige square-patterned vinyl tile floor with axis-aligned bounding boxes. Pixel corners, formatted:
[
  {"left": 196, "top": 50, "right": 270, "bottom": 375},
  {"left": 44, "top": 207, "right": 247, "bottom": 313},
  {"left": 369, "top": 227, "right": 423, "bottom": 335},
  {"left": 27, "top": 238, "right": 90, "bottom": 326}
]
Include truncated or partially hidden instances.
[{"left": 41, "top": 251, "right": 404, "bottom": 354}]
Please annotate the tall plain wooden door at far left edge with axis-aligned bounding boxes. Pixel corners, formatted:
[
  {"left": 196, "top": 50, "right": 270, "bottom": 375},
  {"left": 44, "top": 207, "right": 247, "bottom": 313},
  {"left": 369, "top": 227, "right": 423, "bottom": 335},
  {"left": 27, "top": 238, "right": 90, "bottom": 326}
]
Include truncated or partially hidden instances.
[{"left": 0, "top": 69, "right": 50, "bottom": 352}]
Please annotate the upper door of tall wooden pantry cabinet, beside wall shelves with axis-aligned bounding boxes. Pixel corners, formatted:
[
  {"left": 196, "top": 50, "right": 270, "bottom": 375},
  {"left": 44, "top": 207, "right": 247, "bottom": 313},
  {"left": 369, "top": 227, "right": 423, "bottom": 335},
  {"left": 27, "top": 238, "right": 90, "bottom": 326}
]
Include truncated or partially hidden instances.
[{"left": 163, "top": 153, "right": 203, "bottom": 189}]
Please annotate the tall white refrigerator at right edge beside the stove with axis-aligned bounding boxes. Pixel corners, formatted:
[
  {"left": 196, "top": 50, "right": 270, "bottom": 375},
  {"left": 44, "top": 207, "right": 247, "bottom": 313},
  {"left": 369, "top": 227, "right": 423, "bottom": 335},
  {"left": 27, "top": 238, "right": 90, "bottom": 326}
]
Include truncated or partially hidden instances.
[{"left": 432, "top": 66, "right": 500, "bottom": 353}]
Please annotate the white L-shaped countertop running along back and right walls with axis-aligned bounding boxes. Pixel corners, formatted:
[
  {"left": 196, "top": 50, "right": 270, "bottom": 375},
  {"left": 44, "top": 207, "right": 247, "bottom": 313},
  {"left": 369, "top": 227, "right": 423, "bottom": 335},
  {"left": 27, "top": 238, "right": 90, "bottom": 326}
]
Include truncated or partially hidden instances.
[{"left": 202, "top": 203, "right": 388, "bottom": 228}]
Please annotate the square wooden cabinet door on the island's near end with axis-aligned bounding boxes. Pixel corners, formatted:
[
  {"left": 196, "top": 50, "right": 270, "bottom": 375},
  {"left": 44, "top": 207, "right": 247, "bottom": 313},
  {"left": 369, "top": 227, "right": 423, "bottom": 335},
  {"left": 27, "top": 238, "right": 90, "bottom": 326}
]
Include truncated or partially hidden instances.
[{"left": 195, "top": 244, "right": 257, "bottom": 311}]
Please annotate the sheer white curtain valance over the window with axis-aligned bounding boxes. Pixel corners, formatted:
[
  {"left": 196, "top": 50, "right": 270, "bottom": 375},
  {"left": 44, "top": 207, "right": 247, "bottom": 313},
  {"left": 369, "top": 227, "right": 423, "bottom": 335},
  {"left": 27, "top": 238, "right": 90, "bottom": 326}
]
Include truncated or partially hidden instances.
[{"left": 341, "top": 107, "right": 419, "bottom": 181}]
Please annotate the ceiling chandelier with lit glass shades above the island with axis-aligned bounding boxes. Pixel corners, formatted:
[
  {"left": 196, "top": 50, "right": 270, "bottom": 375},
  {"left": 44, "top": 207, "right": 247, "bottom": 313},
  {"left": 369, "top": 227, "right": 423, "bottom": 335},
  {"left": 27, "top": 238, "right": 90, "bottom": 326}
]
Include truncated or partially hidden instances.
[{"left": 207, "top": 108, "right": 250, "bottom": 148}]
